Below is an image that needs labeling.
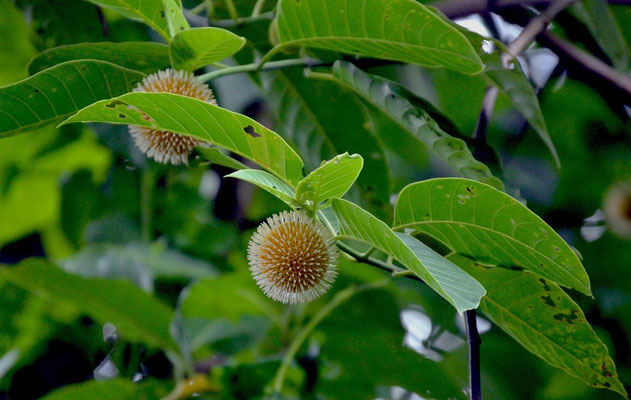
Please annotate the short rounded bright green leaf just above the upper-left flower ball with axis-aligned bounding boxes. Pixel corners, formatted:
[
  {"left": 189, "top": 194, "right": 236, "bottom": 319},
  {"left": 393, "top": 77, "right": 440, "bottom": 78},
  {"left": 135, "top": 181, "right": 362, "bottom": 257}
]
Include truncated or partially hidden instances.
[{"left": 169, "top": 28, "right": 245, "bottom": 71}]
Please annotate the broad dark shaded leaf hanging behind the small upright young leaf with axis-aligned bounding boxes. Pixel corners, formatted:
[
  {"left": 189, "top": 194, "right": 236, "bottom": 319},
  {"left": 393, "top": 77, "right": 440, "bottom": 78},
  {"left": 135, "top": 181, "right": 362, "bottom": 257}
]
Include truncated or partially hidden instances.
[{"left": 263, "top": 68, "right": 391, "bottom": 202}]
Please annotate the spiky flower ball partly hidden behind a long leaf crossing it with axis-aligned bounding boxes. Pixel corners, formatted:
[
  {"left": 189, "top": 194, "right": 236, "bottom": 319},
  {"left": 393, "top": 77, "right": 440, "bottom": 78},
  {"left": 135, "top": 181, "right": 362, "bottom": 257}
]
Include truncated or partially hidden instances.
[{"left": 129, "top": 68, "right": 217, "bottom": 165}]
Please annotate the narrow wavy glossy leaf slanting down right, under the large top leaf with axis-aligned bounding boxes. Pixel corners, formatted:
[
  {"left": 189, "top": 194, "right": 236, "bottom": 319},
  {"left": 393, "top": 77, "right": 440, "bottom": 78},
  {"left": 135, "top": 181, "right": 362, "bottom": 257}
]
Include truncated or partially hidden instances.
[{"left": 326, "top": 61, "right": 504, "bottom": 189}]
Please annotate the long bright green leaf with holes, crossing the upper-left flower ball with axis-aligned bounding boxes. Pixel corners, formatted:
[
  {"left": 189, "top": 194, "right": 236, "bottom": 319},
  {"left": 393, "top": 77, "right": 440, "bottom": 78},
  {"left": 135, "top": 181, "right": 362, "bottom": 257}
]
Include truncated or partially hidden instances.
[{"left": 63, "top": 93, "right": 303, "bottom": 185}]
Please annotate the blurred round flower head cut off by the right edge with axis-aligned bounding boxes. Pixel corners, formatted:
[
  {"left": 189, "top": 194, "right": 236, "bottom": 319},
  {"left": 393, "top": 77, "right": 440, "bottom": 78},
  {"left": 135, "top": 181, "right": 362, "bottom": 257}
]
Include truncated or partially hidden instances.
[{"left": 603, "top": 182, "right": 631, "bottom": 239}]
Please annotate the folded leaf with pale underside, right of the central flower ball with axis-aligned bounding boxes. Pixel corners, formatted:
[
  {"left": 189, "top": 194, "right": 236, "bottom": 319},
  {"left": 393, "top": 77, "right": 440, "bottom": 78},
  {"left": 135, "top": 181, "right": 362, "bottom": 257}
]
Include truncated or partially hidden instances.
[{"left": 333, "top": 199, "right": 485, "bottom": 313}]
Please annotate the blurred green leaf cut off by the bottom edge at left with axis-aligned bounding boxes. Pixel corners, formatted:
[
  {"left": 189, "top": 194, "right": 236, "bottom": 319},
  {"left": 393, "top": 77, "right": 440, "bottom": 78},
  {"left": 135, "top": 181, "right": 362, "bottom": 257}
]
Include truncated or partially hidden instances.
[{"left": 41, "top": 378, "right": 168, "bottom": 400}]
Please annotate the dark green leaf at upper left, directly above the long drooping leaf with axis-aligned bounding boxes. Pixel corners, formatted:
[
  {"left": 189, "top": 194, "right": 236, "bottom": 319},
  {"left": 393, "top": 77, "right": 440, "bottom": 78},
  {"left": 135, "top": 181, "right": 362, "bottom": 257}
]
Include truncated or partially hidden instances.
[{"left": 28, "top": 42, "right": 171, "bottom": 75}]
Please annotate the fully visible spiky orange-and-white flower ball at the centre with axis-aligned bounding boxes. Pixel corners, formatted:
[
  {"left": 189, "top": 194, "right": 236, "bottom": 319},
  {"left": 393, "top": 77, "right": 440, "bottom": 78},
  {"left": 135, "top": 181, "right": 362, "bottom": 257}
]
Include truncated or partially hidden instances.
[{"left": 248, "top": 211, "right": 339, "bottom": 304}]
